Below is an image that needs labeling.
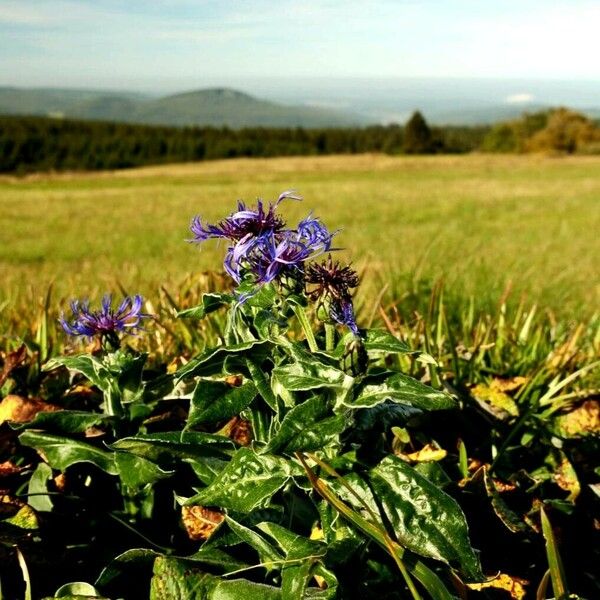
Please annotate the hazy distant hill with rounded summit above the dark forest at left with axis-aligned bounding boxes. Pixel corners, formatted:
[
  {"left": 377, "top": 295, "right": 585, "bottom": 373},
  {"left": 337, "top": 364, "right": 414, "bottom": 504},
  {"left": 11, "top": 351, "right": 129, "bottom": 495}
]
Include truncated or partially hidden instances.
[{"left": 0, "top": 87, "right": 365, "bottom": 128}]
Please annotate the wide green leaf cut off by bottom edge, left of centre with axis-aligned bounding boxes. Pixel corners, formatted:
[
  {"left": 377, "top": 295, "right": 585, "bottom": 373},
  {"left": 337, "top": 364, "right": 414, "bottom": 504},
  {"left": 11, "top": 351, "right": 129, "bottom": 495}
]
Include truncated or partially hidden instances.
[{"left": 150, "top": 556, "right": 281, "bottom": 600}]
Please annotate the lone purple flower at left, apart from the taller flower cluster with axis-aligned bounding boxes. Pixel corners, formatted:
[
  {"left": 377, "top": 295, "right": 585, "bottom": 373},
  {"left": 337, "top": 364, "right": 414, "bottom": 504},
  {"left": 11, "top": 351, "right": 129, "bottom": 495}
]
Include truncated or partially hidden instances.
[{"left": 59, "top": 294, "right": 150, "bottom": 340}]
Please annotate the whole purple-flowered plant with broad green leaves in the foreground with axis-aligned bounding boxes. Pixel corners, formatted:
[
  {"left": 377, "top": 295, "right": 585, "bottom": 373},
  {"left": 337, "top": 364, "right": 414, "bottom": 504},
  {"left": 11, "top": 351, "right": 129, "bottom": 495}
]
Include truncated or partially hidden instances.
[{"left": 31, "top": 192, "right": 482, "bottom": 600}]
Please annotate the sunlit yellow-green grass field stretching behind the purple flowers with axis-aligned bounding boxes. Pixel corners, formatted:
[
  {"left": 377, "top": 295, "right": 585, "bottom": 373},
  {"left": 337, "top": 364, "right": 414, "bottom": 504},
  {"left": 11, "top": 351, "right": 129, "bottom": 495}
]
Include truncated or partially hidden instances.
[{"left": 0, "top": 155, "right": 600, "bottom": 319}]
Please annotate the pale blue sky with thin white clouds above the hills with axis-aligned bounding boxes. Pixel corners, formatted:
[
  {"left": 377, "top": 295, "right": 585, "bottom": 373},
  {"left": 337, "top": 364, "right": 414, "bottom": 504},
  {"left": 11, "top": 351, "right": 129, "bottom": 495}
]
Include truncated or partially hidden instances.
[{"left": 0, "top": 0, "right": 600, "bottom": 91}]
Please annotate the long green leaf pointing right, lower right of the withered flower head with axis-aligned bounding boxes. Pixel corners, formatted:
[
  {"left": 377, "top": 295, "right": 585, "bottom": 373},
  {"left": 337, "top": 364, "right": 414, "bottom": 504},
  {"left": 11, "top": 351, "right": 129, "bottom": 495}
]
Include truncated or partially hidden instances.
[{"left": 346, "top": 373, "right": 458, "bottom": 410}]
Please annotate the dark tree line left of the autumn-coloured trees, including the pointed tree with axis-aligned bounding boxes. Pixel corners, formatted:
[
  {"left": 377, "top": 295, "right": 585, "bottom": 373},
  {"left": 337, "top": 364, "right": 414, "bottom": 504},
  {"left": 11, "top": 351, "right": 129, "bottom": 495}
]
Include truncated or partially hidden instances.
[{"left": 0, "top": 113, "right": 489, "bottom": 174}]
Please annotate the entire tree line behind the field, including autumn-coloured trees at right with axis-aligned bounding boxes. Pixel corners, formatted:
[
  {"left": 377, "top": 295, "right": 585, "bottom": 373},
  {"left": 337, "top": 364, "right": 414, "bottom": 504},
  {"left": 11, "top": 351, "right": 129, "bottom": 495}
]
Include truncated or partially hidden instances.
[{"left": 0, "top": 108, "right": 600, "bottom": 174}]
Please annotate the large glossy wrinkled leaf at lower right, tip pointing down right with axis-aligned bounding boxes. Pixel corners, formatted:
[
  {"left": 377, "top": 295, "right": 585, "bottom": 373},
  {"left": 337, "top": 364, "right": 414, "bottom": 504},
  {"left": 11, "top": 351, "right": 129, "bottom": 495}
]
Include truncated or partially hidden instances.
[{"left": 370, "top": 456, "right": 482, "bottom": 581}]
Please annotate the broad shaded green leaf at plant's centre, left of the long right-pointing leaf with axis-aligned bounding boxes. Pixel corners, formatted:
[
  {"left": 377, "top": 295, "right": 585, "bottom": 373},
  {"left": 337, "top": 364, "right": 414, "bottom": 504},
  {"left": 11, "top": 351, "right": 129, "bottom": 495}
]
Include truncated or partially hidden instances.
[{"left": 264, "top": 396, "right": 348, "bottom": 454}]
